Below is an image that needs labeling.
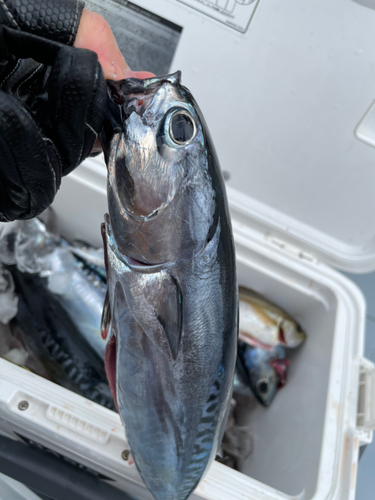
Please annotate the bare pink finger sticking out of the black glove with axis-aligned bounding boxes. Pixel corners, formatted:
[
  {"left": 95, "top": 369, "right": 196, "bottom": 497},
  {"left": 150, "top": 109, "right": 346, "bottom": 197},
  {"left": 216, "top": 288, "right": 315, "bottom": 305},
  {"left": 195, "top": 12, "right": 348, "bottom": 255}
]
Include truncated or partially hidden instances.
[{"left": 74, "top": 9, "right": 129, "bottom": 80}]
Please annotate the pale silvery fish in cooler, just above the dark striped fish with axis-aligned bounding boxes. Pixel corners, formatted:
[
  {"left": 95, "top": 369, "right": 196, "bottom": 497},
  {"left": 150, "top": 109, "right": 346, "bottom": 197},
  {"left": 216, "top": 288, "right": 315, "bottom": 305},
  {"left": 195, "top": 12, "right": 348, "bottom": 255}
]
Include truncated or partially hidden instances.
[{"left": 0, "top": 219, "right": 107, "bottom": 361}]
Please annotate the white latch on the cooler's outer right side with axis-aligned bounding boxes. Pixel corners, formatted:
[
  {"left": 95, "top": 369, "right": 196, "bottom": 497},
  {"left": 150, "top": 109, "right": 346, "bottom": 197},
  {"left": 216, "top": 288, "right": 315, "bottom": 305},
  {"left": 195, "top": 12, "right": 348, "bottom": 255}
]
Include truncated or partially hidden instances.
[{"left": 357, "top": 358, "right": 375, "bottom": 444}]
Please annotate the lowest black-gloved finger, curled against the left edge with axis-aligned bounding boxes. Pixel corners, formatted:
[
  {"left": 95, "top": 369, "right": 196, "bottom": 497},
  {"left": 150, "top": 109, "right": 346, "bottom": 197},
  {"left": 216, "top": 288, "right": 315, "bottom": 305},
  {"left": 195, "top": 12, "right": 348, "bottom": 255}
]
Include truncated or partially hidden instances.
[{"left": 0, "top": 92, "right": 61, "bottom": 221}]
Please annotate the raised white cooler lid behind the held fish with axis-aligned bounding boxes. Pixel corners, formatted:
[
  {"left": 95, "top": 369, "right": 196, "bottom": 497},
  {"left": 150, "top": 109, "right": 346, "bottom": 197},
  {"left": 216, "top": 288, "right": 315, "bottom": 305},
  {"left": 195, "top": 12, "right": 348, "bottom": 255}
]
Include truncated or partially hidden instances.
[{"left": 88, "top": 0, "right": 375, "bottom": 272}]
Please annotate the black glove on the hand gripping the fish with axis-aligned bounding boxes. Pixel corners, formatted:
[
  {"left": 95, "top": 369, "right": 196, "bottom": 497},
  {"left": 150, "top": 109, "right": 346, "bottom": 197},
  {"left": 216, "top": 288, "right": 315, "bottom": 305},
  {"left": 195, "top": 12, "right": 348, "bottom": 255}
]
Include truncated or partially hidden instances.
[{"left": 0, "top": 0, "right": 106, "bottom": 221}]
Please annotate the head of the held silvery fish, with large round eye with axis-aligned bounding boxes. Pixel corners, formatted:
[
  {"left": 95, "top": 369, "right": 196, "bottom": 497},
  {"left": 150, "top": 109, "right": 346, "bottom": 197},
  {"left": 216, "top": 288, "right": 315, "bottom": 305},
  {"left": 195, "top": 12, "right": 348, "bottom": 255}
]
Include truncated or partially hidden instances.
[{"left": 102, "top": 72, "right": 214, "bottom": 264}]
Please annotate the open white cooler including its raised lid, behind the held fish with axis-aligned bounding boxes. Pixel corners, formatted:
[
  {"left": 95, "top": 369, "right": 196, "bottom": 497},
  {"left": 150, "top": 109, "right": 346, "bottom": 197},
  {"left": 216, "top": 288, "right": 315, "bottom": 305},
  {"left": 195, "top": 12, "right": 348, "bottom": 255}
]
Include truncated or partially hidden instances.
[{"left": 0, "top": 0, "right": 375, "bottom": 500}]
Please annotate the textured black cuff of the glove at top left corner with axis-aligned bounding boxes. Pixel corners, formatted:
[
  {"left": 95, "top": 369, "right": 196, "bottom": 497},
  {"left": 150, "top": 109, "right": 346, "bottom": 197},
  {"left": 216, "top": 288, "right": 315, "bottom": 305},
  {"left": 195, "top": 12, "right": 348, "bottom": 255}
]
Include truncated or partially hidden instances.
[{"left": 0, "top": 0, "right": 84, "bottom": 45}]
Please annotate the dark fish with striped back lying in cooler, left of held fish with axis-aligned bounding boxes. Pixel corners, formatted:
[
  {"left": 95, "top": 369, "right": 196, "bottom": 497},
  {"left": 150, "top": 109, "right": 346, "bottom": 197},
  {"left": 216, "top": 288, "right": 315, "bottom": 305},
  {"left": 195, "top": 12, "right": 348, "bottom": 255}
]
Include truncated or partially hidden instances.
[{"left": 8, "top": 266, "right": 115, "bottom": 410}]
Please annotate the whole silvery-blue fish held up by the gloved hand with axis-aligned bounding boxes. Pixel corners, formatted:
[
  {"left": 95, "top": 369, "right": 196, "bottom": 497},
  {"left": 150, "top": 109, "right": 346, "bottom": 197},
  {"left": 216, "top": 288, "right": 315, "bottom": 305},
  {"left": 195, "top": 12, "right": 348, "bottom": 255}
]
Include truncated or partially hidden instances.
[{"left": 102, "top": 72, "right": 238, "bottom": 500}]
